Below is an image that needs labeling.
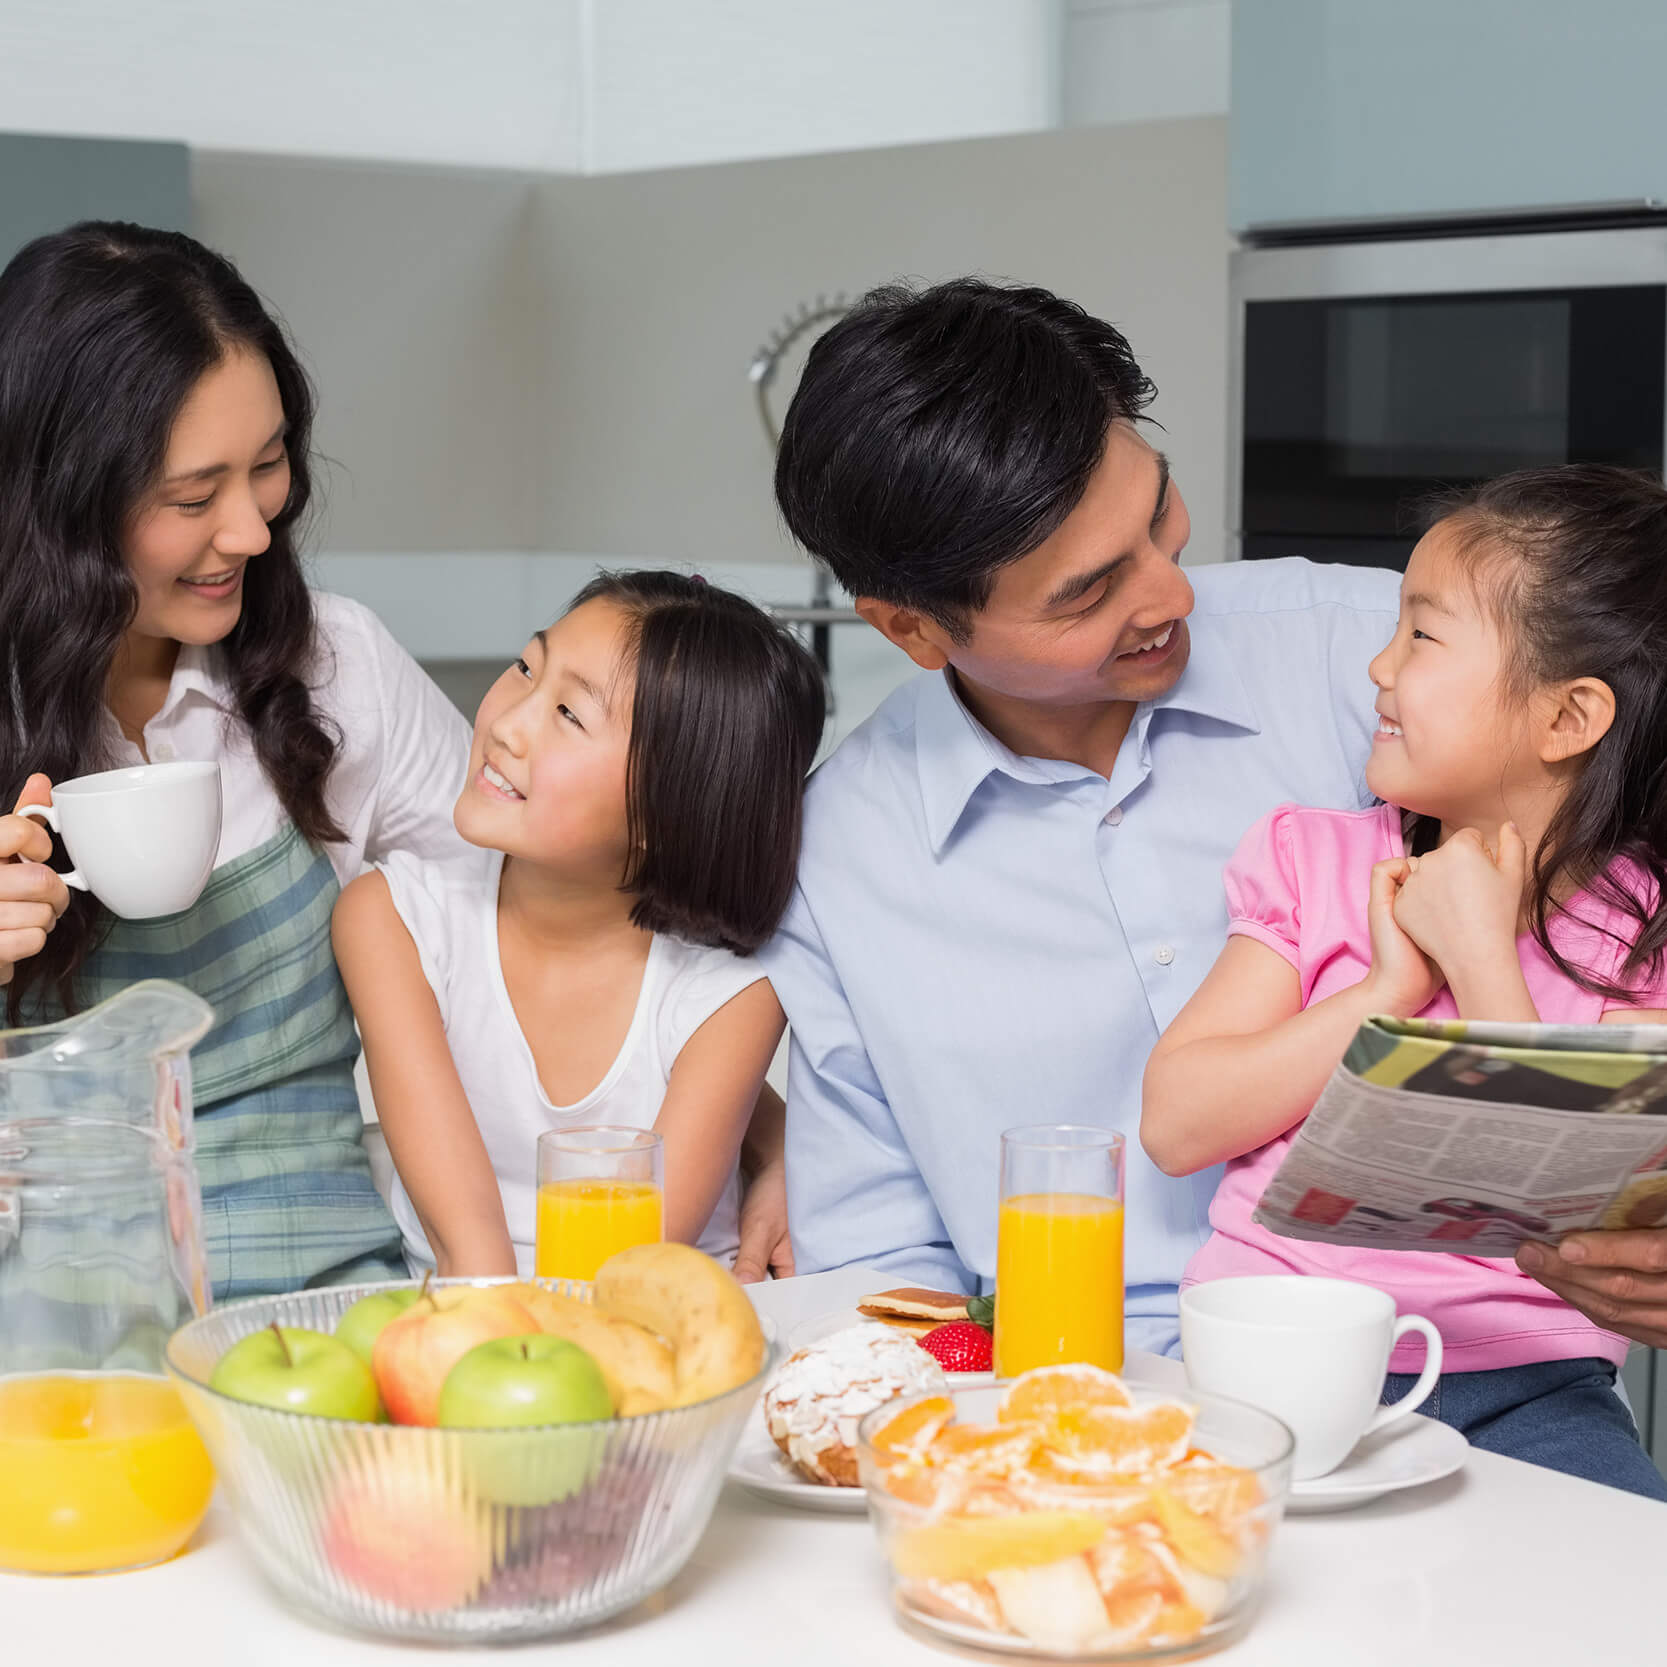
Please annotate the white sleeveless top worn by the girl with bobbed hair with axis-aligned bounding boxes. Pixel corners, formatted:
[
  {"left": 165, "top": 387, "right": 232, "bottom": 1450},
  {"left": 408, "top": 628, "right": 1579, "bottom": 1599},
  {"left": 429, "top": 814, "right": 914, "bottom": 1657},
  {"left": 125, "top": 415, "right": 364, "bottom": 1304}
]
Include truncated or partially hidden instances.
[{"left": 380, "top": 850, "right": 763, "bottom": 1279}]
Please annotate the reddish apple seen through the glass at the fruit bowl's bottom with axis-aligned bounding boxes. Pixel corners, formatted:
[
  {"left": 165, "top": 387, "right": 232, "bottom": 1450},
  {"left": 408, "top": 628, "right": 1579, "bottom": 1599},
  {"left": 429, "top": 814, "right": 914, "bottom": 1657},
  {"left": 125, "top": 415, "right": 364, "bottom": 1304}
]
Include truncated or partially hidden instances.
[{"left": 323, "top": 1459, "right": 492, "bottom": 1612}]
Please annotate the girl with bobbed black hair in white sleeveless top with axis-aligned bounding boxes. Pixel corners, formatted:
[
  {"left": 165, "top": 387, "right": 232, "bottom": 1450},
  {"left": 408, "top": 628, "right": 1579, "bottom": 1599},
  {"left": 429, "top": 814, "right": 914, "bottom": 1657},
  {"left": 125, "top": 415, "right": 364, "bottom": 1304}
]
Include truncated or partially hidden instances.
[{"left": 333, "top": 572, "right": 823, "bottom": 1275}]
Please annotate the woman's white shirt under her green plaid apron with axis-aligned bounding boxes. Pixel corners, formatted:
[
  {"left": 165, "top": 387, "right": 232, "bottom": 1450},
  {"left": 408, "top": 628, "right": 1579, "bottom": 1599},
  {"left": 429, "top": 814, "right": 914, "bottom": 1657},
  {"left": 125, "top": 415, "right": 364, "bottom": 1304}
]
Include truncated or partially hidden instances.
[{"left": 105, "top": 592, "right": 470, "bottom": 885}]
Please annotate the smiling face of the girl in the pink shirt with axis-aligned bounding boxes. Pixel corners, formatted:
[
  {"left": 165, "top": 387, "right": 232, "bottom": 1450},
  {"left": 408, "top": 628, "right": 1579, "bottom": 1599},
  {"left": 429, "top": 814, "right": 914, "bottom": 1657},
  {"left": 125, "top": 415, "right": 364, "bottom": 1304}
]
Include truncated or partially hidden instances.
[{"left": 1365, "top": 522, "right": 1547, "bottom": 827}]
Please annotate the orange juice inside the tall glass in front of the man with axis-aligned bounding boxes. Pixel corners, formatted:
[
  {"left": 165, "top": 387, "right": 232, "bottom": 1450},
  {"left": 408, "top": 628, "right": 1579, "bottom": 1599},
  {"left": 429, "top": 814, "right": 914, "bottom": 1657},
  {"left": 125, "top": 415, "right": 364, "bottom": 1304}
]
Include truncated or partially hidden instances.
[{"left": 995, "top": 1192, "right": 1124, "bottom": 1377}]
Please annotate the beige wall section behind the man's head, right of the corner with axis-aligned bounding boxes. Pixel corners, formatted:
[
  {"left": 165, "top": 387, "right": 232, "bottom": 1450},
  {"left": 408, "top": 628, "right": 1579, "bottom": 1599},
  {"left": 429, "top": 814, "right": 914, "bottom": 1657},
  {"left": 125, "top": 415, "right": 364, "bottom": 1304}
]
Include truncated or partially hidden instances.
[{"left": 537, "top": 120, "right": 1227, "bottom": 562}]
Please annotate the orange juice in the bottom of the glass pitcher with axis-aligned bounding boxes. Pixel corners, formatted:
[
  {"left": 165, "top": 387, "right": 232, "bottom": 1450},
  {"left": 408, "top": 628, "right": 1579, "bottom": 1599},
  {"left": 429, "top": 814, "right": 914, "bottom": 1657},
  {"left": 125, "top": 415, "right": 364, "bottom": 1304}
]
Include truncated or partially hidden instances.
[{"left": 0, "top": 1372, "right": 213, "bottom": 1574}]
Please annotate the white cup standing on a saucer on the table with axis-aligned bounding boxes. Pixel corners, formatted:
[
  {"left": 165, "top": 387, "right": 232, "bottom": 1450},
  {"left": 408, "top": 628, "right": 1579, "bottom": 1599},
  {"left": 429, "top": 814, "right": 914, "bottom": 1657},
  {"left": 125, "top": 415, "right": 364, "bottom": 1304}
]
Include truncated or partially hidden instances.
[{"left": 1180, "top": 1274, "right": 1442, "bottom": 1482}]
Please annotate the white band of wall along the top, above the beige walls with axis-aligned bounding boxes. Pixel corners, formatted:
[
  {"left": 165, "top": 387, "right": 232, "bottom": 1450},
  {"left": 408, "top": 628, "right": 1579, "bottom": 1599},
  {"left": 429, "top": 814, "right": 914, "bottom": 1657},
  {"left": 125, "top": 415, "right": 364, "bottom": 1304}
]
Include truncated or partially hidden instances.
[{"left": 0, "top": 0, "right": 1060, "bottom": 172}]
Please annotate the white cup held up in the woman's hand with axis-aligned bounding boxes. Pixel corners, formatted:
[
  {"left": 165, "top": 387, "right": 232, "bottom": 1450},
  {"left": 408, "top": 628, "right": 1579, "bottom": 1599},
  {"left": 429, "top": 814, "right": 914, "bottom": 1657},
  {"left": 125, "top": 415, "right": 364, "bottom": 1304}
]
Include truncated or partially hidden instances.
[{"left": 17, "top": 763, "right": 220, "bottom": 920}]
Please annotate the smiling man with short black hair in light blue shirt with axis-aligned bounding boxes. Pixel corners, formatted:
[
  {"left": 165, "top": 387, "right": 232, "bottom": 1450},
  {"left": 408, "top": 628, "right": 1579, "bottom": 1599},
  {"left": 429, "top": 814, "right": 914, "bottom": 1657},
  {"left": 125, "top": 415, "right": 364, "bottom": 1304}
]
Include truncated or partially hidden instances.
[{"left": 765, "top": 280, "right": 1397, "bottom": 1349}]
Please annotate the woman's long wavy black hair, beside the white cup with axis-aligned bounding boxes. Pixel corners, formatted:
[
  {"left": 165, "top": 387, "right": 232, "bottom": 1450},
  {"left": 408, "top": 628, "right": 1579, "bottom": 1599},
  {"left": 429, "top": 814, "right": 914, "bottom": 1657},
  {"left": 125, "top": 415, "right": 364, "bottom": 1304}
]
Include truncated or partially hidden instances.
[{"left": 0, "top": 220, "right": 343, "bottom": 1024}]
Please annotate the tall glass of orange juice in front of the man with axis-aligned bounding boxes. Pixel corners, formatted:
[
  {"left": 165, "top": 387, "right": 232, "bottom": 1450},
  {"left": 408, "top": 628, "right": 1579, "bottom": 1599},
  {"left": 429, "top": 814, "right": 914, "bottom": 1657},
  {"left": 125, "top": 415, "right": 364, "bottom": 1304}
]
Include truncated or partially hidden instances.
[{"left": 995, "top": 1124, "right": 1124, "bottom": 1377}]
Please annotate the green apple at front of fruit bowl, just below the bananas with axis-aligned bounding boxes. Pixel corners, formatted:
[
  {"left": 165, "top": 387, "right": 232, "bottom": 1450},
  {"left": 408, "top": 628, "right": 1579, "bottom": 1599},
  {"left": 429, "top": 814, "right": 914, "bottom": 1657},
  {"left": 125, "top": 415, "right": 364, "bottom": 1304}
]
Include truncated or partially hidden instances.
[{"left": 440, "top": 1334, "right": 613, "bottom": 1507}]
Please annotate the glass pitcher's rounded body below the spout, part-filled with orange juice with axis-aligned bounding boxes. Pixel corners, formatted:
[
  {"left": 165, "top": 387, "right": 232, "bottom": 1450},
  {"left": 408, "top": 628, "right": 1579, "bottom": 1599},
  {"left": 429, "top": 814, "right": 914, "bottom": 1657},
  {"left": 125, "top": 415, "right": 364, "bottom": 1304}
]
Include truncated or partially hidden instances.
[{"left": 0, "top": 1117, "right": 213, "bottom": 1574}]
